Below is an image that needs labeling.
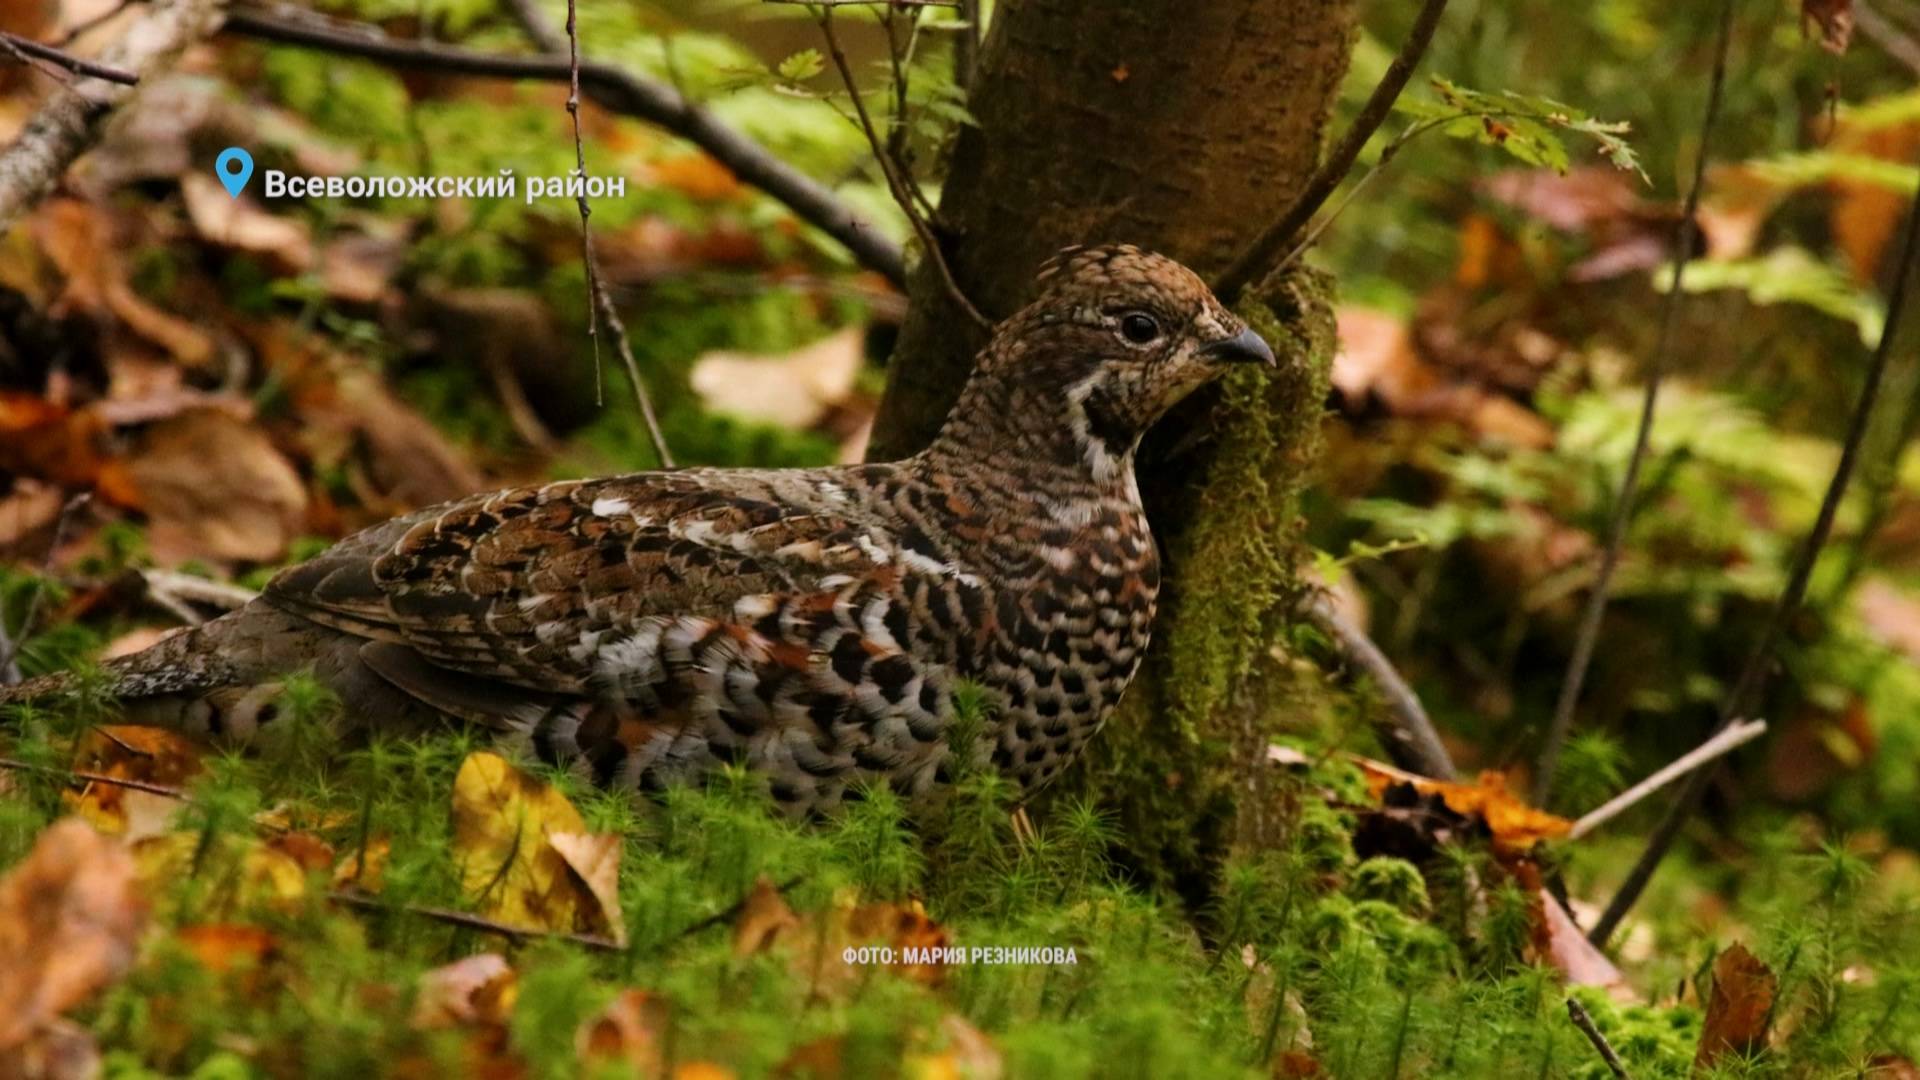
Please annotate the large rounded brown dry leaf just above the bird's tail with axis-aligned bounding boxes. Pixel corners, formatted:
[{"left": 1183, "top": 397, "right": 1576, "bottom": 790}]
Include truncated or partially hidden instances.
[{"left": 127, "top": 409, "right": 307, "bottom": 563}]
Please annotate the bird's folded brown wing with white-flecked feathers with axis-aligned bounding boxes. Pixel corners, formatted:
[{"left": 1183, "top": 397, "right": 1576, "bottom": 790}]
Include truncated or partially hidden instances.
[{"left": 267, "top": 469, "right": 897, "bottom": 694}]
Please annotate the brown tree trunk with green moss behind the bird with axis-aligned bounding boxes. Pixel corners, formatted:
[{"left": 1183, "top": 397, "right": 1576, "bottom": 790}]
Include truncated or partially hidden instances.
[{"left": 872, "top": 0, "right": 1354, "bottom": 892}]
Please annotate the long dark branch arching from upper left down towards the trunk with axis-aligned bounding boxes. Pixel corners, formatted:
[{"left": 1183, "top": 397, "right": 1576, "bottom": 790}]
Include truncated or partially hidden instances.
[{"left": 224, "top": 0, "right": 906, "bottom": 288}]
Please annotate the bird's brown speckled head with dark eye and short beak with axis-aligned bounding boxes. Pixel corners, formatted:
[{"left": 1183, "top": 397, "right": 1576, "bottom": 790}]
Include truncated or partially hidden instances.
[{"left": 981, "top": 244, "right": 1275, "bottom": 468}]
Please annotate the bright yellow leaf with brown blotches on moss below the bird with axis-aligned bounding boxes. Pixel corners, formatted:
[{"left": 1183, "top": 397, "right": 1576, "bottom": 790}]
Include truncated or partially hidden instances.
[{"left": 453, "top": 751, "right": 626, "bottom": 942}]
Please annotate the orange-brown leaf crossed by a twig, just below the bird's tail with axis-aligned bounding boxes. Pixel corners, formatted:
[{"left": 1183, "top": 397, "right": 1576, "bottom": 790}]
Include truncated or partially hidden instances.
[{"left": 61, "top": 724, "right": 205, "bottom": 842}]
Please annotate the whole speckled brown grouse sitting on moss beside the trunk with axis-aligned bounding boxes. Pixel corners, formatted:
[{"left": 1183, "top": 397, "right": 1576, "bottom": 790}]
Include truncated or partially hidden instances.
[{"left": 3, "top": 246, "right": 1271, "bottom": 813}]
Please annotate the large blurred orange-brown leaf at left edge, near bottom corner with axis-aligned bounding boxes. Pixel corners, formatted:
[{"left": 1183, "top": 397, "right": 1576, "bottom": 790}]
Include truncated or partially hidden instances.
[{"left": 0, "top": 817, "right": 146, "bottom": 1051}]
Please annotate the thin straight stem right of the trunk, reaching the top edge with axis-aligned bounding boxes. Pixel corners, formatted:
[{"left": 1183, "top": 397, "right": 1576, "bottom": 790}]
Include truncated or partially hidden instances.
[{"left": 1532, "top": 0, "right": 1734, "bottom": 807}]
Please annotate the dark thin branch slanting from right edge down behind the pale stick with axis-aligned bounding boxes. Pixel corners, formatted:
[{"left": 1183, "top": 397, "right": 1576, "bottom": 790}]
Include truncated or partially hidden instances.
[{"left": 1588, "top": 141, "right": 1920, "bottom": 944}]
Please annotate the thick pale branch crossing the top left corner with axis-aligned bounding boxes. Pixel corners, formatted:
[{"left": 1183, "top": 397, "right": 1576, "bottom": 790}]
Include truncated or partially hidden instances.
[{"left": 0, "top": 0, "right": 219, "bottom": 233}]
